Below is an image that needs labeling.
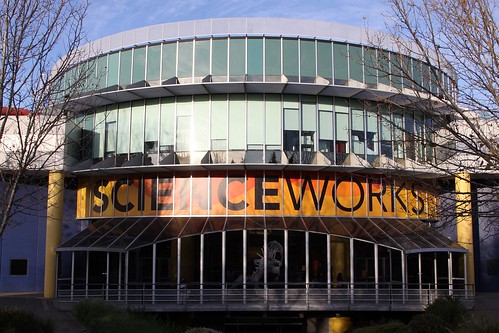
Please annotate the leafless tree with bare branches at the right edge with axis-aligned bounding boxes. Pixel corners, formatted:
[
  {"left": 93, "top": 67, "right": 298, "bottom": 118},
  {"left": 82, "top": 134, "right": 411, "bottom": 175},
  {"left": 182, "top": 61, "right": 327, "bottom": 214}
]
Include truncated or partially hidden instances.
[{"left": 371, "top": 0, "right": 499, "bottom": 239}]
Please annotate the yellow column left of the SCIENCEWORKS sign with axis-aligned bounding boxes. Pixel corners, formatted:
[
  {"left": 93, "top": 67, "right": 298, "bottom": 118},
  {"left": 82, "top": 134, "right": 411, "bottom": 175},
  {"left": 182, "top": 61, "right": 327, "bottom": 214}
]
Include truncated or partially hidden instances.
[{"left": 43, "top": 171, "right": 64, "bottom": 298}]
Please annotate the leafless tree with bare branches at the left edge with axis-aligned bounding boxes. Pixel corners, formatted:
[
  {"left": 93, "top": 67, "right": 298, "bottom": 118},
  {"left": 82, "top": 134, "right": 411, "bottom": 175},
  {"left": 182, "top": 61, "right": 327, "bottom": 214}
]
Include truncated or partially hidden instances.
[{"left": 0, "top": 0, "right": 88, "bottom": 237}]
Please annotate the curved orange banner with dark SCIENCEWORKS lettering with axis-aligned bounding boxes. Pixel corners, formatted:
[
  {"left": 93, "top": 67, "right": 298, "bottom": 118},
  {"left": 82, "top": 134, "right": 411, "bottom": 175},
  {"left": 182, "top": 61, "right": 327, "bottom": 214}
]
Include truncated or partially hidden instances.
[{"left": 77, "top": 172, "right": 437, "bottom": 219}]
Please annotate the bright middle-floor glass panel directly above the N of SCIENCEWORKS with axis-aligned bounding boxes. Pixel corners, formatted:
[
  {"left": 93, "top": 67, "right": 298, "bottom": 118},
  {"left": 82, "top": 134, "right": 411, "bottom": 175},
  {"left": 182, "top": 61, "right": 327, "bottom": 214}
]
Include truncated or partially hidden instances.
[{"left": 193, "top": 95, "right": 210, "bottom": 151}]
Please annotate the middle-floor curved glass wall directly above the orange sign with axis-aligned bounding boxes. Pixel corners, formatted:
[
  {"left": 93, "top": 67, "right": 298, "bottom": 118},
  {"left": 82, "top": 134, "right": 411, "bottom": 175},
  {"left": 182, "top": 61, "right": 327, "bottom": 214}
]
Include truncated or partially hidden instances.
[{"left": 79, "top": 94, "right": 433, "bottom": 165}]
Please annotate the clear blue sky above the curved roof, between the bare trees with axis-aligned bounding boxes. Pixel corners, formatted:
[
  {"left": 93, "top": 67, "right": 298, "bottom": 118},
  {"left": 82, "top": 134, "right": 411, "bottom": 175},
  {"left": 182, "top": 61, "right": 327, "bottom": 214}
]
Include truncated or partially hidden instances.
[{"left": 85, "top": 0, "right": 388, "bottom": 40}]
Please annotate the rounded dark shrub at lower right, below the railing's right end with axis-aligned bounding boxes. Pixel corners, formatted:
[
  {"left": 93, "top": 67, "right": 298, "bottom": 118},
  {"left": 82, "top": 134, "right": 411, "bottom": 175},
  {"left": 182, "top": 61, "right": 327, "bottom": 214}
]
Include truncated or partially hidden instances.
[{"left": 426, "top": 296, "right": 467, "bottom": 329}]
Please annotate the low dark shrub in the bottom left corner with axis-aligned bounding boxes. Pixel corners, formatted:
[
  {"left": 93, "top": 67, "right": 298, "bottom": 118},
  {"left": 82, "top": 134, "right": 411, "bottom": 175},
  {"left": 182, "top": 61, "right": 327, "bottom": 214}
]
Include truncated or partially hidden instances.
[{"left": 0, "top": 307, "right": 54, "bottom": 333}]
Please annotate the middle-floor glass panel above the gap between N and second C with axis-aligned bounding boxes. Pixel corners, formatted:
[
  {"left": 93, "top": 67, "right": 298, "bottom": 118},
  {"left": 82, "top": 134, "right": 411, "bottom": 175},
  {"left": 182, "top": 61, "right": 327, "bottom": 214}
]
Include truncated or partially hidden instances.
[{"left": 211, "top": 95, "right": 227, "bottom": 150}]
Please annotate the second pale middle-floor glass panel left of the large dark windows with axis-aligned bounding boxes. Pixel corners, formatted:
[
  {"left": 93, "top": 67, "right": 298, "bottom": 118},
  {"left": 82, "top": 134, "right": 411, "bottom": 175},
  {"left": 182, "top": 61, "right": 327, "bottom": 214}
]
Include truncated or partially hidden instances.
[{"left": 248, "top": 94, "right": 265, "bottom": 150}]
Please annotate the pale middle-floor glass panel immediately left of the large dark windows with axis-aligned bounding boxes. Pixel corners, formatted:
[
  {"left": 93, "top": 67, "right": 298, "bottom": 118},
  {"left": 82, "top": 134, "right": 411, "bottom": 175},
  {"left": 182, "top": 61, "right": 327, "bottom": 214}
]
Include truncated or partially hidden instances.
[{"left": 265, "top": 95, "right": 282, "bottom": 150}]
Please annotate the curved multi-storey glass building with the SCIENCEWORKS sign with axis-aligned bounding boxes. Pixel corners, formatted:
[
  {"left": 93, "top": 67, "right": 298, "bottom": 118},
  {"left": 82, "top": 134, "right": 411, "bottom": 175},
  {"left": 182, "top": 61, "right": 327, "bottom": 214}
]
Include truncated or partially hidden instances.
[{"left": 55, "top": 18, "right": 474, "bottom": 326}]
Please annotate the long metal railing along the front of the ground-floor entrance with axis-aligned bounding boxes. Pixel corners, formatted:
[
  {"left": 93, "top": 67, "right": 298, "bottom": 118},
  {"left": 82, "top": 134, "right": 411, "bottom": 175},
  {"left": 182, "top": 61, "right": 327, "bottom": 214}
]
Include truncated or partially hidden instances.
[{"left": 57, "top": 281, "right": 475, "bottom": 312}]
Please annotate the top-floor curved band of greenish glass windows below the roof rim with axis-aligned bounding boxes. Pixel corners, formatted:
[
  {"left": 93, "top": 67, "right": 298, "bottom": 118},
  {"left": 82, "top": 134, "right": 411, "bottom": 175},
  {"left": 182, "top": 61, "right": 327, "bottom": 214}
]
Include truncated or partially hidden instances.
[{"left": 66, "top": 36, "right": 455, "bottom": 98}]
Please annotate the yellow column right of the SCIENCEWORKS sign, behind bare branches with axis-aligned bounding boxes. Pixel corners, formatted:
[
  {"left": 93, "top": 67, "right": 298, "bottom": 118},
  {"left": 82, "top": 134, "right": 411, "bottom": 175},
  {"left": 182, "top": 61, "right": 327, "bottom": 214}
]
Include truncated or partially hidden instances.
[{"left": 455, "top": 173, "right": 475, "bottom": 284}]
